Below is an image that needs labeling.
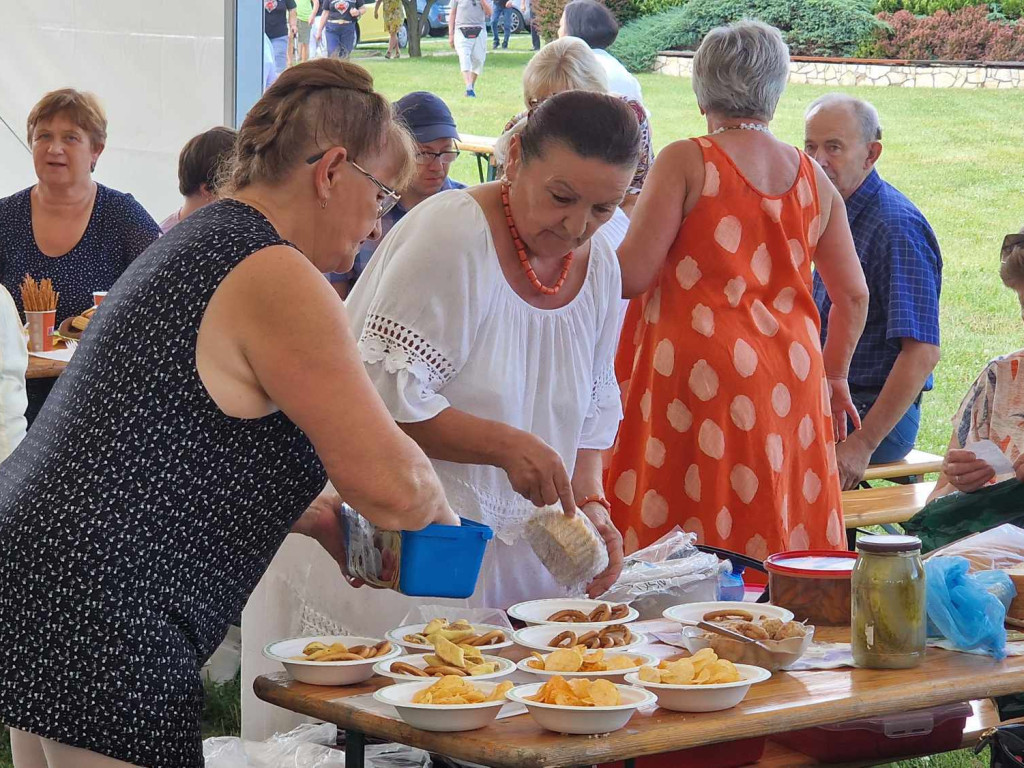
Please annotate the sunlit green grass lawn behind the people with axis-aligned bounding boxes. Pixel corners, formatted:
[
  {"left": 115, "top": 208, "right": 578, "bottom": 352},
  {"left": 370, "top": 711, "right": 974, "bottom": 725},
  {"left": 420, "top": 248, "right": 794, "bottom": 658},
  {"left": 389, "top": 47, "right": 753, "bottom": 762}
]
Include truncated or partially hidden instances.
[{"left": 0, "top": 46, "right": 1024, "bottom": 768}]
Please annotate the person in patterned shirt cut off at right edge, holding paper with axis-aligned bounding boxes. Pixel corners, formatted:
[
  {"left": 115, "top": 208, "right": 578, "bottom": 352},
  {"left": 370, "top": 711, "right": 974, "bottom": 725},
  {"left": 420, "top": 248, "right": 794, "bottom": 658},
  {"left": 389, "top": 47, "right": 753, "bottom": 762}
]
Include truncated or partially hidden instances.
[{"left": 929, "top": 229, "right": 1024, "bottom": 501}]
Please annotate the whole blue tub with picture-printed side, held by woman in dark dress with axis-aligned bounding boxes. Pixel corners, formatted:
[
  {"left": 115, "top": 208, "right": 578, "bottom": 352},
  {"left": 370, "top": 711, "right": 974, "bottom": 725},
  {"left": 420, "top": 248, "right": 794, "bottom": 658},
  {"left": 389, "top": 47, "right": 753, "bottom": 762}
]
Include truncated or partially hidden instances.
[{"left": 341, "top": 506, "right": 495, "bottom": 598}]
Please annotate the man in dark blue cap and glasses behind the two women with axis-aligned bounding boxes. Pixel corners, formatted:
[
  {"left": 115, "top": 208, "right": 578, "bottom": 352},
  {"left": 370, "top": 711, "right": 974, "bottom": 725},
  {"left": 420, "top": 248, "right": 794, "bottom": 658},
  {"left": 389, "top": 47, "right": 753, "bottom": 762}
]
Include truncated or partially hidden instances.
[{"left": 328, "top": 91, "right": 466, "bottom": 298}]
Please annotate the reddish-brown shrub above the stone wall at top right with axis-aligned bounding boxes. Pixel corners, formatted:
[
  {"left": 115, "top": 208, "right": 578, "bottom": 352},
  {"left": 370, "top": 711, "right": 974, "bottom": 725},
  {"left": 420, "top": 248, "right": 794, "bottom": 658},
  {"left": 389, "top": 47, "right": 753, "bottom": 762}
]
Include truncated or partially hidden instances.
[{"left": 874, "top": 5, "right": 1024, "bottom": 61}]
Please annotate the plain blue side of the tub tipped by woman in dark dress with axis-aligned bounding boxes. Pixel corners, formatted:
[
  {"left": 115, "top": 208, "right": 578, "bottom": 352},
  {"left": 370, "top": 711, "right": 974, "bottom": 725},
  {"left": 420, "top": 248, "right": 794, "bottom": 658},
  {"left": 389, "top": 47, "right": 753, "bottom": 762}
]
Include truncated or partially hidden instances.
[{"left": 398, "top": 517, "right": 495, "bottom": 597}]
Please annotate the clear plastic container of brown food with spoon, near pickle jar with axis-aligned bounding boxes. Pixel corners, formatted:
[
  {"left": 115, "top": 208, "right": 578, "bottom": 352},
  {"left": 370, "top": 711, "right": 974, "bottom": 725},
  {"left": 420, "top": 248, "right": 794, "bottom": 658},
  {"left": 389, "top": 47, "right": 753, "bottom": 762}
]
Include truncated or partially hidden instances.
[{"left": 682, "top": 618, "right": 814, "bottom": 672}]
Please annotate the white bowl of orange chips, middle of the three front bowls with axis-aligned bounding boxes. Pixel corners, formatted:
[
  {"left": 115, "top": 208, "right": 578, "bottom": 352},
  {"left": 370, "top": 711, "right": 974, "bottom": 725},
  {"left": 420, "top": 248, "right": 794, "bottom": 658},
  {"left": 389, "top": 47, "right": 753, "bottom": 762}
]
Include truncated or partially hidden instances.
[{"left": 507, "top": 676, "right": 656, "bottom": 735}]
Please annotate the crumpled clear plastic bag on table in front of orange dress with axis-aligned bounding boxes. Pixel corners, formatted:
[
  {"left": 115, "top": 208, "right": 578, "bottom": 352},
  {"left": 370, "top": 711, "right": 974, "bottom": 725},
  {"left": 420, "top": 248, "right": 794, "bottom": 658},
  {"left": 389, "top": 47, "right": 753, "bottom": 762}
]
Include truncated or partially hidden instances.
[{"left": 601, "top": 525, "right": 728, "bottom": 621}]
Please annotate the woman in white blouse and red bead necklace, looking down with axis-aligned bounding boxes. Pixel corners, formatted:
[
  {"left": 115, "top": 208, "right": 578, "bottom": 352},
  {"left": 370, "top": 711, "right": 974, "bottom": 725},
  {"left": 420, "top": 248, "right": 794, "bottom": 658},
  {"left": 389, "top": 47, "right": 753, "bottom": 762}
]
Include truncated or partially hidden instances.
[{"left": 347, "top": 91, "right": 639, "bottom": 608}]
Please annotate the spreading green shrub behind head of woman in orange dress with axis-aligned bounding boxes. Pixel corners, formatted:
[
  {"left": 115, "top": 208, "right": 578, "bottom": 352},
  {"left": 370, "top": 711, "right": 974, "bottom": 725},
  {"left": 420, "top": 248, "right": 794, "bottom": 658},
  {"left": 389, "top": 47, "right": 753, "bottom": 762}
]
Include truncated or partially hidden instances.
[{"left": 611, "top": 0, "right": 882, "bottom": 72}]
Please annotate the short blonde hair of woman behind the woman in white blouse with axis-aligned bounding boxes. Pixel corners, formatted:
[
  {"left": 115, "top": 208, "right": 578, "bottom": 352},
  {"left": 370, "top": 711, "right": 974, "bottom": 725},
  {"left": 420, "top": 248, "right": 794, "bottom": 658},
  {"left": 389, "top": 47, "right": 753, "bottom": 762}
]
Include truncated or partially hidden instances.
[{"left": 522, "top": 37, "right": 608, "bottom": 106}]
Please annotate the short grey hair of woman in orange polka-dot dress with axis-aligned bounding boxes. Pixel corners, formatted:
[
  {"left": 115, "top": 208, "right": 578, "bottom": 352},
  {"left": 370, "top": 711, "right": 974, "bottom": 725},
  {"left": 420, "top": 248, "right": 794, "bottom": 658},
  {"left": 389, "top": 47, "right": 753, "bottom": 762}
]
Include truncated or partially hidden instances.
[{"left": 693, "top": 19, "right": 790, "bottom": 121}]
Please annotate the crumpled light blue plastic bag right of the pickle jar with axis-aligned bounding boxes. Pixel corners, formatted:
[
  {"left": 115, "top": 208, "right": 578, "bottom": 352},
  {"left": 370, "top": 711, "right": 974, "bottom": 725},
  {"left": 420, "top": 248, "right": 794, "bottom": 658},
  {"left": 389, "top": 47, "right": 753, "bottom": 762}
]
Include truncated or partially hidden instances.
[{"left": 925, "top": 557, "right": 1014, "bottom": 658}]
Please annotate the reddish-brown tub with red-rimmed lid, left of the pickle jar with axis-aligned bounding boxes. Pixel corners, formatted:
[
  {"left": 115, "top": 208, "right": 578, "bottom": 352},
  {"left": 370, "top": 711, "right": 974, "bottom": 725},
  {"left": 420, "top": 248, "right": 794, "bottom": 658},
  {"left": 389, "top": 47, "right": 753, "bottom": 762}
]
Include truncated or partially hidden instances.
[{"left": 765, "top": 550, "right": 857, "bottom": 627}]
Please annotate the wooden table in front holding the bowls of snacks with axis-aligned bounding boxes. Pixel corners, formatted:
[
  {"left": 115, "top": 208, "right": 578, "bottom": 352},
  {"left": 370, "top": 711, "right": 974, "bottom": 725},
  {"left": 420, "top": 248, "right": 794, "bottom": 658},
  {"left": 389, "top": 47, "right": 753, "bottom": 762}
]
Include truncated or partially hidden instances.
[{"left": 254, "top": 628, "right": 1024, "bottom": 768}]
